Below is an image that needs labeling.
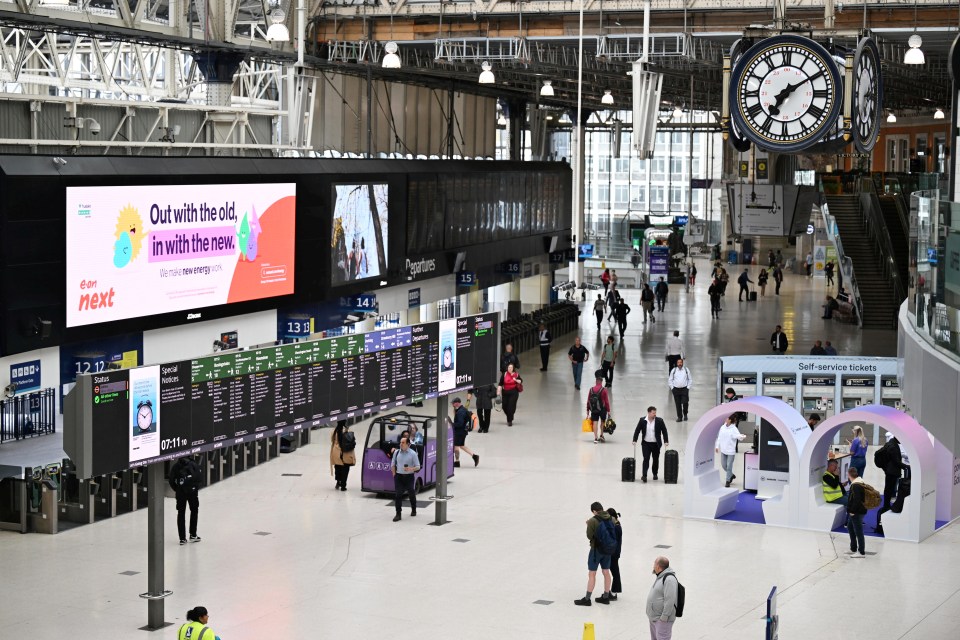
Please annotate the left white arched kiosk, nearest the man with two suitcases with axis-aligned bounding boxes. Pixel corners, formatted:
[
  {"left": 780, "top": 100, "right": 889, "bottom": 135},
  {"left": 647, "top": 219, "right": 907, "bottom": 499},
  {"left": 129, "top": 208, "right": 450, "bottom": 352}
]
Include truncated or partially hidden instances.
[{"left": 683, "top": 396, "right": 808, "bottom": 527}]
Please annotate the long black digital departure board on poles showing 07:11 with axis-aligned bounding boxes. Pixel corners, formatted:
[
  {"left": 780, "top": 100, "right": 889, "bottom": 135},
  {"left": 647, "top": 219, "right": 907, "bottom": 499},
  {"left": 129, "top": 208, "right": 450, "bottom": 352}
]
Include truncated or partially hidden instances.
[{"left": 64, "top": 314, "right": 499, "bottom": 475}]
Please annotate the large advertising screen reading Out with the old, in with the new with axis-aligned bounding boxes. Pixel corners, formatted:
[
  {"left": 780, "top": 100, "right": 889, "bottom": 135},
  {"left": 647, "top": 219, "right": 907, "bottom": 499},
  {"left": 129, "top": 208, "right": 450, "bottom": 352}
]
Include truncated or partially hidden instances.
[{"left": 67, "top": 183, "right": 296, "bottom": 327}]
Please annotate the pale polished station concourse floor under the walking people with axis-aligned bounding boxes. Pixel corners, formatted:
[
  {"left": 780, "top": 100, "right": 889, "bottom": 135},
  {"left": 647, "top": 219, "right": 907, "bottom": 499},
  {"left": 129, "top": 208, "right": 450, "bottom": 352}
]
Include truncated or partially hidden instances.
[{"left": 0, "top": 263, "right": 960, "bottom": 640}]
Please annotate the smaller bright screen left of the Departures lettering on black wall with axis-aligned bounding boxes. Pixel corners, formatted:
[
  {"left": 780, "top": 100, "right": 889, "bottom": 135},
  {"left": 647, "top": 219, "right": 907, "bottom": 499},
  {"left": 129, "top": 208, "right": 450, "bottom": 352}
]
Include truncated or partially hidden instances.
[{"left": 330, "top": 184, "right": 388, "bottom": 285}]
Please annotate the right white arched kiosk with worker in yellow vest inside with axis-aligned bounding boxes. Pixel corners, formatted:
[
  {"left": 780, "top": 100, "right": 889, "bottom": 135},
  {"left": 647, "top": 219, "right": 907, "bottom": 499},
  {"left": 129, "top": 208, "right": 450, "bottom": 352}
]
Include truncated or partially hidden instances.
[{"left": 791, "top": 404, "right": 937, "bottom": 542}]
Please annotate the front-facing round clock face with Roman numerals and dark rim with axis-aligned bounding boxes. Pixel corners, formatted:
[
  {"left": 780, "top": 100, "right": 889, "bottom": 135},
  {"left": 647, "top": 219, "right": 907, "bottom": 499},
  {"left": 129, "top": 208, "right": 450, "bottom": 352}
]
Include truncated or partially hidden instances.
[{"left": 730, "top": 35, "right": 843, "bottom": 152}]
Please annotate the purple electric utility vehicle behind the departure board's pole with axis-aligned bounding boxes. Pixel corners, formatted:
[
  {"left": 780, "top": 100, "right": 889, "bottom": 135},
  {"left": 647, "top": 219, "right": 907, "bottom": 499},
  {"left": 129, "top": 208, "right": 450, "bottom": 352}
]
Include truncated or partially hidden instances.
[{"left": 360, "top": 411, "right": 453, "bottom": 493}]
